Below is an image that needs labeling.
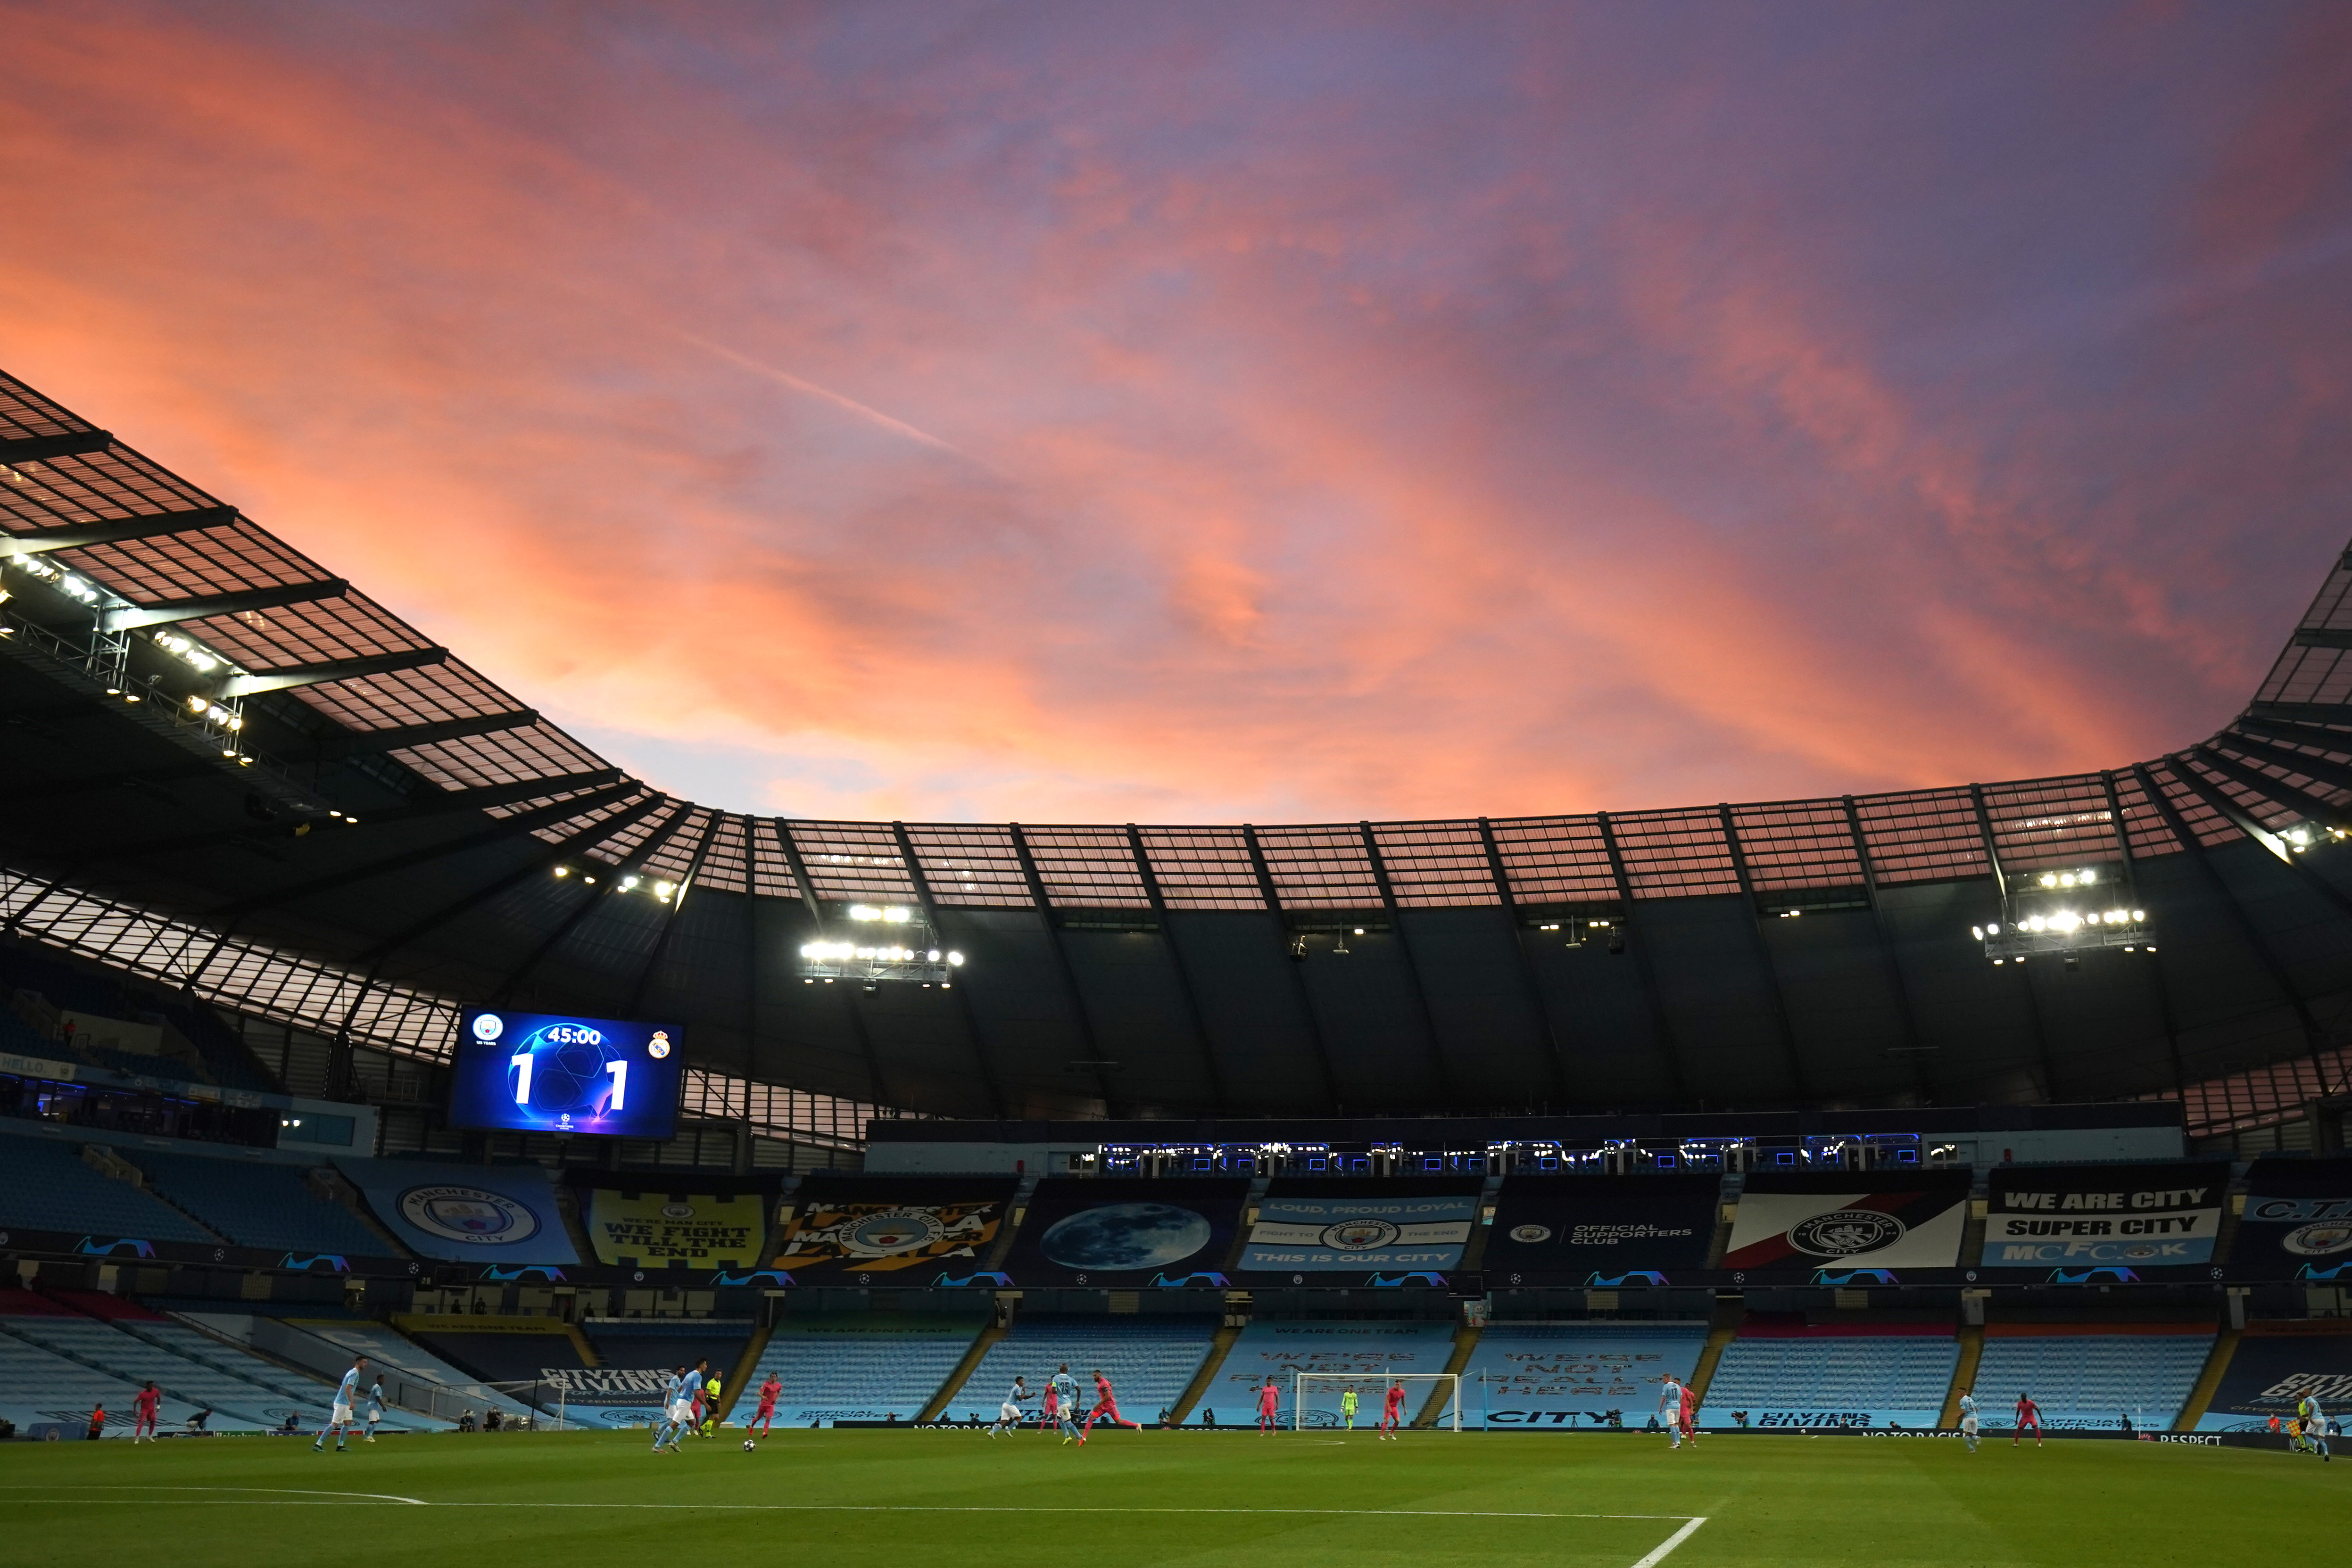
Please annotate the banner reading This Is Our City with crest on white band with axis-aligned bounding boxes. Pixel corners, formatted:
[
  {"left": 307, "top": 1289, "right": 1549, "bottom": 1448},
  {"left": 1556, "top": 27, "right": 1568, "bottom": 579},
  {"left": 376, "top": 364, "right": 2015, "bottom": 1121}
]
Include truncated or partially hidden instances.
[{"left": 1240, "top": 1175, "right": 1482, "bottom": 1286}]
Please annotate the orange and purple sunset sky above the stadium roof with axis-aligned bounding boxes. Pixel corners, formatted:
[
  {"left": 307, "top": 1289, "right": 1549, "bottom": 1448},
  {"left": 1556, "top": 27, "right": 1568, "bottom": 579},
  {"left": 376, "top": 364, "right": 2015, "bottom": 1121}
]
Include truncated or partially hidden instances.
[{"left": 0, "top": 0, "right": 2352, "bottom": 823}]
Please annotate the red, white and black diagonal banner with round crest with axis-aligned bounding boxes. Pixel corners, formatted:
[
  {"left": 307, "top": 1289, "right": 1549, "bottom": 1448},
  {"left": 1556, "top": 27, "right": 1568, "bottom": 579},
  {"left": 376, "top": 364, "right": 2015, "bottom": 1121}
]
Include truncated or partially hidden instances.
[{"left": 1722, "top": 1171, "right": 1969, "bottom": 1286}]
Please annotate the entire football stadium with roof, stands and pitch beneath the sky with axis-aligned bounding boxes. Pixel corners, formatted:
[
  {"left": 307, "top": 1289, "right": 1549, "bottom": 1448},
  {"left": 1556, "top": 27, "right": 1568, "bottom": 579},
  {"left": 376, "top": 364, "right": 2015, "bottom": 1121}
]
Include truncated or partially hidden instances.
[{"left": 0, "top": 6, "right": 2352, "bottom": 1568}]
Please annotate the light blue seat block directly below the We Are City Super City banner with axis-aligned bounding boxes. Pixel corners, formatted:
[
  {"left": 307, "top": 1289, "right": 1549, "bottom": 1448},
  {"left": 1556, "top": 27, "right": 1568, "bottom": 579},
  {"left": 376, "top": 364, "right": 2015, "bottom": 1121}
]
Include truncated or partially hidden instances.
[{"left": 1976, "top": 1323, "right": 2213, "bottom": 1432}]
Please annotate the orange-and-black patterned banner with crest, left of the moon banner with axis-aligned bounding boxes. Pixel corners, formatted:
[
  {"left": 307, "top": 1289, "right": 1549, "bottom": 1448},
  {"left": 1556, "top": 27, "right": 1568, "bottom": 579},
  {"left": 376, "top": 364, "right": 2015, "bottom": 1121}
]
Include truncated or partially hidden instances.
[{"left": 774, "top": 1175, "right": 1019, "bottom": 1286}]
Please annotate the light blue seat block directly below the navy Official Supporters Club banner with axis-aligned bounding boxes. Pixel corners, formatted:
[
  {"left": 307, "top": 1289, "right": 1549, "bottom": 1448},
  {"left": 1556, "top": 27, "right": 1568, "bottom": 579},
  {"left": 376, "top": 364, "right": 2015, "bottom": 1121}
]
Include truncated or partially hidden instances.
[{"left": 1463, "top": 1321, "right": 1707, "bottom": 1432}]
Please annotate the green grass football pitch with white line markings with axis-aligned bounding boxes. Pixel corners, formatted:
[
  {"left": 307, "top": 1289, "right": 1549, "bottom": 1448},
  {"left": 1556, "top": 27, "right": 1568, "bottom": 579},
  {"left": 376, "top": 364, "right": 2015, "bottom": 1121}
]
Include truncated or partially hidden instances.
[{"left": 0, "top": 1429, "right": 2352, "bottom": 1568}]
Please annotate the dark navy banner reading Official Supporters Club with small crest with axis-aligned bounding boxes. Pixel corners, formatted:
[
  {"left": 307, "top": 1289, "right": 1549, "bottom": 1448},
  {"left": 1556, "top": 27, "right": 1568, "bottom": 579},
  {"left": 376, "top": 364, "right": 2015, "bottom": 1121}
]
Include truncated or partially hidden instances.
[{"left": 1482, "top": 1175, "right": 1722, "bottom": 1286}]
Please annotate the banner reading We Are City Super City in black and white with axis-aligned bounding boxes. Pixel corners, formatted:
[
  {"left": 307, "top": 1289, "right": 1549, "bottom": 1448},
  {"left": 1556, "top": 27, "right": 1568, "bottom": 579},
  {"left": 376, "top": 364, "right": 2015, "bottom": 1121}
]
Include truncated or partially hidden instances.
[{"left": 1978, "top": 1161, "right": 2230, "bottom": 1284}]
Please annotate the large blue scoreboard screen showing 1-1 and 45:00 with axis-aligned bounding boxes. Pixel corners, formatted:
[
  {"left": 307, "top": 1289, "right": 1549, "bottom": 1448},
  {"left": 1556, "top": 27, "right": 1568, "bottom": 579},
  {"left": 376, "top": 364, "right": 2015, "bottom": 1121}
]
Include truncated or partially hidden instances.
[{"left": 449, "top": 1008, "right": 682, "bottom": 1138}]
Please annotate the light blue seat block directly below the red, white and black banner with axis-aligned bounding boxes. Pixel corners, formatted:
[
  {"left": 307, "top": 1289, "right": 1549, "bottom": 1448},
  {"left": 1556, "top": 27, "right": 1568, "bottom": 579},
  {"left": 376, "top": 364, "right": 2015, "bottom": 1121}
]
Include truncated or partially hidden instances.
[{"left": 1698, "top": 1314, "right": 1959, "bottom": 1427}]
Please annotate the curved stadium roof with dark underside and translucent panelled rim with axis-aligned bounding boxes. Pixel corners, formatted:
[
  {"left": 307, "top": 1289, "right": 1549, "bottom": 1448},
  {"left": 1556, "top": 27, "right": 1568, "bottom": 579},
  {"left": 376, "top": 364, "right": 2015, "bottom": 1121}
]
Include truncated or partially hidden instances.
[{"left": 0, "top": 376, "right": 2352, "bottom": 1117}]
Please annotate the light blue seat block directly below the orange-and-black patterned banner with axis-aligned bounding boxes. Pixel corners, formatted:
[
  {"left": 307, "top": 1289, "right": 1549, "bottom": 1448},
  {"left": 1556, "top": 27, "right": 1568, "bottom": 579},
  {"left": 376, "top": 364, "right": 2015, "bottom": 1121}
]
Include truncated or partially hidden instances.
[{"left": 734, "top": 1312, "right": 987, "bottom": 1427}]
